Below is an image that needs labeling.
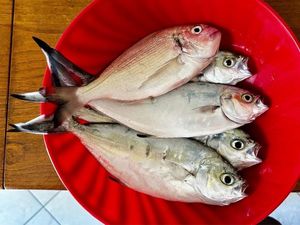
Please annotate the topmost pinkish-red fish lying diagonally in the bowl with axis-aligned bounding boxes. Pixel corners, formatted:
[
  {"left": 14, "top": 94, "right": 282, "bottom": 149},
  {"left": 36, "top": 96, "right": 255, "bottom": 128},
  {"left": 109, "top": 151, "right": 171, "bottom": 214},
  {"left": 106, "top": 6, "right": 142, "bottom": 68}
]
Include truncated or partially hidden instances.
[{"left": 28, "top": 24, "right": 221, "bottom": 123}]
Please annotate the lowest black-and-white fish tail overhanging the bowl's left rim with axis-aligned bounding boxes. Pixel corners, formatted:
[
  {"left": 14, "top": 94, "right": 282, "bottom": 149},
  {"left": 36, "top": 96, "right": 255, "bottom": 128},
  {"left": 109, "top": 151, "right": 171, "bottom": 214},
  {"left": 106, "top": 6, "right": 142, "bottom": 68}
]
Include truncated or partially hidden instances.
[{"left": 7, "top": 115, "right": 67, "bottom": 134}]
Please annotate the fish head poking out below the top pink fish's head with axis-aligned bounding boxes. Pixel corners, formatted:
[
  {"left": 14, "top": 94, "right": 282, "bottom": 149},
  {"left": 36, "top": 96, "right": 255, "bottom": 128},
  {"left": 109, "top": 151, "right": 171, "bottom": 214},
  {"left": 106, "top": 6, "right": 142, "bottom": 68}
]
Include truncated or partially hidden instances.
[{"left": 201, "top": 51, "right": 252, "bottom": 85}]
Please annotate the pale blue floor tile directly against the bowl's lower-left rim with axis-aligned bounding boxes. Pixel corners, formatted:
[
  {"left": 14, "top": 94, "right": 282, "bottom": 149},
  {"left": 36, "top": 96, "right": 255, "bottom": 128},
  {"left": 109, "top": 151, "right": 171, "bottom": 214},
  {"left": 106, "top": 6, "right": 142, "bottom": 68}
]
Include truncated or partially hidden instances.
[{"left": 45, "top": 191, "right": 102, "bottom": 225}]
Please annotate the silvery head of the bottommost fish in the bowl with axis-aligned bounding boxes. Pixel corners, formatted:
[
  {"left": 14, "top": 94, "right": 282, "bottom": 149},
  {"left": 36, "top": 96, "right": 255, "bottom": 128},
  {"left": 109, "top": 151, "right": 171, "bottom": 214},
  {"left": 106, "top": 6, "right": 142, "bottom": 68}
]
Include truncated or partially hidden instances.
[{"left": 196, "top": 156, "right": 247, "bottom": 205}]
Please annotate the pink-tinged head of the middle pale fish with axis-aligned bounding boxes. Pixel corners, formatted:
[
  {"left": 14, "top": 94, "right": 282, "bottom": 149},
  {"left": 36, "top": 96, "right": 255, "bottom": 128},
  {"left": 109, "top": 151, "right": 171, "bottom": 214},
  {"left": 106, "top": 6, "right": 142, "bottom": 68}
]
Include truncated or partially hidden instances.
[{"left": 220, "top": 86, "right": 269, "bottom": 124}]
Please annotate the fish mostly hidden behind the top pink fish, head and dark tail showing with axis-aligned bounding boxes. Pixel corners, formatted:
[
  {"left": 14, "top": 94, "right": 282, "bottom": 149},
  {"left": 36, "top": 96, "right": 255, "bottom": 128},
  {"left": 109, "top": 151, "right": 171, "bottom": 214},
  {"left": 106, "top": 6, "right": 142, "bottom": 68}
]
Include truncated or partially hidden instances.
[{"left": 33, "top": 41, "right": 252, "bottom": 87}]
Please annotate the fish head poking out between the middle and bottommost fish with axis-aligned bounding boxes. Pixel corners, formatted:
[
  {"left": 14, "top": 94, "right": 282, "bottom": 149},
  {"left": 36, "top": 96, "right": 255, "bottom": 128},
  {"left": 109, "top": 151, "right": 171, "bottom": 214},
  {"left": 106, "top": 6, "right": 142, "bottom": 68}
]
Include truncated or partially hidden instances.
[{"left": 206, "top": 129, "right": 261, "bottom": 169}]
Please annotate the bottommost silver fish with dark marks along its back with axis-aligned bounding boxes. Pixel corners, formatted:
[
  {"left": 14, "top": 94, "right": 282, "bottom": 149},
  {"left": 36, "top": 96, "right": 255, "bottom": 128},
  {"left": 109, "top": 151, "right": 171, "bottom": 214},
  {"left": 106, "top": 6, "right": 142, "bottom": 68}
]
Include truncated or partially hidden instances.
[{"left": 9, "top": 118, "right": 246, "bottom": 205}]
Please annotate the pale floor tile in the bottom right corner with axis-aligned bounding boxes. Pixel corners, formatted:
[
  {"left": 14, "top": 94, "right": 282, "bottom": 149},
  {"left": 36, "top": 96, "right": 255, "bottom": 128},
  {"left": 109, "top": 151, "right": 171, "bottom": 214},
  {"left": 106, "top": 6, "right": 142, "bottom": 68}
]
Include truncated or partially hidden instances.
[{"left": 270, "top": 193, "right": 300, "bottom": 225}]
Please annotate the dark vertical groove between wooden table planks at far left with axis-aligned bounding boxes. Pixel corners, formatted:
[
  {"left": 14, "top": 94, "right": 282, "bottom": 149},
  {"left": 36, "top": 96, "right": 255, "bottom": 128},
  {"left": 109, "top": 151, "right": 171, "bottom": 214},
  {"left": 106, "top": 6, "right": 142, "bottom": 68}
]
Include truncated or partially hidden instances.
[{"left": 2, "top": 0, "right": 15, "bottom": 189}]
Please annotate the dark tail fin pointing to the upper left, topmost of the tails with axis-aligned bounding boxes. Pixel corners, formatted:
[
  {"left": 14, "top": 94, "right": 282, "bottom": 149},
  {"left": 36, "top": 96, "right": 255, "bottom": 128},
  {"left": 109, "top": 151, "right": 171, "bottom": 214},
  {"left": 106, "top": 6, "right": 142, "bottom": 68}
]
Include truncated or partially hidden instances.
[{"left": 32, "top": 37, "right": 96, "bottom": 87}]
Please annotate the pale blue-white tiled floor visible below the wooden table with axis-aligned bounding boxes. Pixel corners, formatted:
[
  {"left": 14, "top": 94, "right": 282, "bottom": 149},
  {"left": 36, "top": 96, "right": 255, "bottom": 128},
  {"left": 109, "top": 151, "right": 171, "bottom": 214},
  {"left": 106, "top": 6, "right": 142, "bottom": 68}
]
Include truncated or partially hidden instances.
[{"left": 0, "top": 190, "right": 300, "bottom": 225}]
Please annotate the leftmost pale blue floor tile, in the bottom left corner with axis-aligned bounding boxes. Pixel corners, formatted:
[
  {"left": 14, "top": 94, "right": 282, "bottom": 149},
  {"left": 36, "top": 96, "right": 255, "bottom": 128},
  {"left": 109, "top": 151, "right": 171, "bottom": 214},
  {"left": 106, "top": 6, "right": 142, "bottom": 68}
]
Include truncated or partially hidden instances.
[{"left": 0, "top": 190, "right": 42, "bottom": 225}]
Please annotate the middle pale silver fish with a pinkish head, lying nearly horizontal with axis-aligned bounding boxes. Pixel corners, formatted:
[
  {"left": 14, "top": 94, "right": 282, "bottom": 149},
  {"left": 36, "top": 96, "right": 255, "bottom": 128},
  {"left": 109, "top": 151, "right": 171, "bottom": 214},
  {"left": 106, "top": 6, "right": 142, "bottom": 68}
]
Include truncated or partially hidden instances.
[{"left": 12, "top": 82, "right": 268, "bottom": 138}]
